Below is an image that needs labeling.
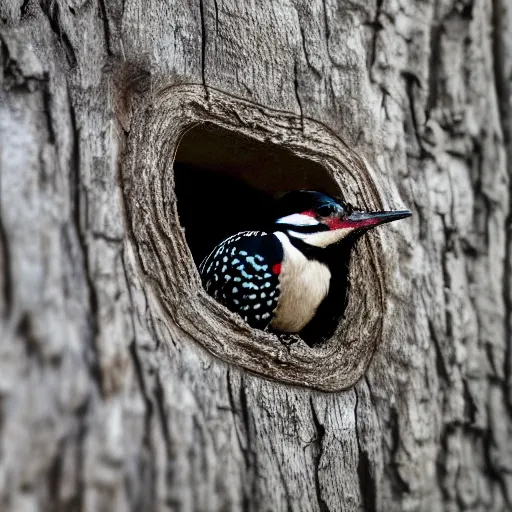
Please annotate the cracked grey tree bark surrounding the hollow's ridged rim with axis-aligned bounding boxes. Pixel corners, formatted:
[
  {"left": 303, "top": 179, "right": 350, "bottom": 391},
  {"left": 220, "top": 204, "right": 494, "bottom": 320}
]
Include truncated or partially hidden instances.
[{"left": 0, "top": 0, "right": 512, "bottom": 512}]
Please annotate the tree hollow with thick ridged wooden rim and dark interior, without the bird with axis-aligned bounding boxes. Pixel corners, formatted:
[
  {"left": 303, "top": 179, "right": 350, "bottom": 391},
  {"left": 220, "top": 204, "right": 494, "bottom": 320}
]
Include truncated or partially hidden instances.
[{"left": 122, "top": 82, "right": 385, "bottom": 391}]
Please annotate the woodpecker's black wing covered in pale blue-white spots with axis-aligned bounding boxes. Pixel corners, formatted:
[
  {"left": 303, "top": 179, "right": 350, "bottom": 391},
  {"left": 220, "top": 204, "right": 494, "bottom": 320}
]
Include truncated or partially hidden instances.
[{"left": 199, "top": 231, "right": 283, "bottom": 329}]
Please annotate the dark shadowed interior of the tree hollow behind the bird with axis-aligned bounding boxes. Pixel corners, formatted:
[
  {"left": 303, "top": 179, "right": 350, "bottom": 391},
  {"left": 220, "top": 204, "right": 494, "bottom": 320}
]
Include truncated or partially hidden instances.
[{"left": 174, "top": 123, "right": 345, "bottom": 339}]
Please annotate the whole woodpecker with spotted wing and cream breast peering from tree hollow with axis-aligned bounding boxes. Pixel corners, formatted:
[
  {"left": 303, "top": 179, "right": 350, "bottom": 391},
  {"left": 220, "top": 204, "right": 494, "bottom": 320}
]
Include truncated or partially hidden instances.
[{"left": 199, "top": 190, "right": 411, "bottom": 334}]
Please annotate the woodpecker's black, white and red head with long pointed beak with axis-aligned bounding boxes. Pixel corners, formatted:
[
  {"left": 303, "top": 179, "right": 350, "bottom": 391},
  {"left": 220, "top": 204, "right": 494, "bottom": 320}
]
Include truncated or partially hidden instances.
[{"left": 273, "top": 190, "right": 412, "bottom": 248}]
